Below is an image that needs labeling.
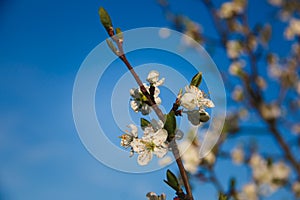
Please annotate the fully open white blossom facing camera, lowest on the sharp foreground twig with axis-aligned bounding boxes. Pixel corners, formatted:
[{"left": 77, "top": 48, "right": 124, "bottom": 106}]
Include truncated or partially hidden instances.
[{"left": 130, "top": 129, "right": 168, "bottom": 165}]
